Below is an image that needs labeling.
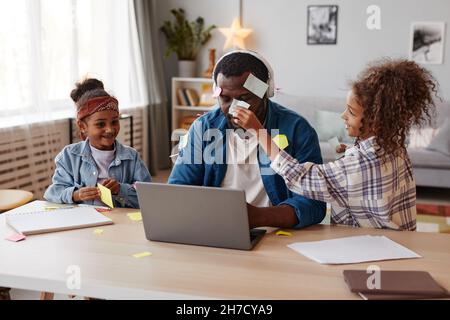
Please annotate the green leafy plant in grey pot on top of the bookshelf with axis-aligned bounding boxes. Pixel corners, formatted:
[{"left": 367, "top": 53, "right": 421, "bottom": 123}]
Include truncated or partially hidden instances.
[{"left": 161, "top": 8, "right": 216, "bottom": 77}]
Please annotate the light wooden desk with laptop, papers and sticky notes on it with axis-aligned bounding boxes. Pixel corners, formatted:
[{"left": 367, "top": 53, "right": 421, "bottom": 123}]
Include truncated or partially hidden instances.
[{"left": 0, "top": 202, "right": 450, "bottom": 299}]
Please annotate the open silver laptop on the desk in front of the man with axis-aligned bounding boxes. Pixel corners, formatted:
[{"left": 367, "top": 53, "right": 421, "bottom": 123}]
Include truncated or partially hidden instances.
[{"left": 136, "top": 182, "right": 266, "bottom": 250}]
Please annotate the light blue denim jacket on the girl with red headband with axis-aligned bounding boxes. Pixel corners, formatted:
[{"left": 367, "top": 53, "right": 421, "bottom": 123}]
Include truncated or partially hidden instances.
[{"left": 44, "top": 140, "right": 151, "bottom": 208}]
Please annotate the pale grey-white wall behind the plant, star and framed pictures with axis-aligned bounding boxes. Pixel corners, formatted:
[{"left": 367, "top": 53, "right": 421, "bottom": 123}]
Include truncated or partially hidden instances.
[{"left": 159, "top": 0, "right": 450, "bottom": 100}]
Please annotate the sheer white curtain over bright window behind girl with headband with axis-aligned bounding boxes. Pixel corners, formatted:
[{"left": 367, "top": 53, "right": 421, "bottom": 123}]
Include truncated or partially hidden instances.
[{"left": 0, "top": 0, "right": 148, "bottom": 127}]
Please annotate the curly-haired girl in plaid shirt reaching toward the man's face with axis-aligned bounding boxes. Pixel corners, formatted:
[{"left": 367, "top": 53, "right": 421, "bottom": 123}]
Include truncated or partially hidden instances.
[{"left": 234, "top": 60, "right": 437, "bottom": 230}]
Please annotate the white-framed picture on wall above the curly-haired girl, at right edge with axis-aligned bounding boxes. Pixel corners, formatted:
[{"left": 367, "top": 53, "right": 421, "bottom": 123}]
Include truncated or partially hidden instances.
[{"left": 409, "top": 22, "right": 445, "bottom": 64}]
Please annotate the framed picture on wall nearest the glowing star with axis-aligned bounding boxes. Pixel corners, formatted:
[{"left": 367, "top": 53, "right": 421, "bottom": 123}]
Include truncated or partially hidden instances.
[{"left": 307, "top": 5, "right": 338, "bottom": 44}]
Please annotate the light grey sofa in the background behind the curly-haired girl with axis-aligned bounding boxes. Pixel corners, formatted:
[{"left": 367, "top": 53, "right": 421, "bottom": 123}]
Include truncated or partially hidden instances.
[{"left": 273, "top": 92, "right": 450, "bottom": 188}]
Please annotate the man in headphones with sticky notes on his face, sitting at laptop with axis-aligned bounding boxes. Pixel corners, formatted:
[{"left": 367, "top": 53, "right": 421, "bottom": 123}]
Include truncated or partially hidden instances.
[{"left": 169, "top": 51, "right": 326, "bottom": 228}]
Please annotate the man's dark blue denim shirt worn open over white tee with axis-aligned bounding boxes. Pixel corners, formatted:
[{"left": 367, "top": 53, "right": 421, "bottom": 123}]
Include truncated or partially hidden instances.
[{"left": 169, "top": 100, "right": 326, "bottom": 228}]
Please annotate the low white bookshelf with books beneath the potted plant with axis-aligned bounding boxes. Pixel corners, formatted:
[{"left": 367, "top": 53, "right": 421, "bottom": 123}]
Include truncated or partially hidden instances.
[{"left": 171, "top": 78, "right": 213, "bottom": 131}]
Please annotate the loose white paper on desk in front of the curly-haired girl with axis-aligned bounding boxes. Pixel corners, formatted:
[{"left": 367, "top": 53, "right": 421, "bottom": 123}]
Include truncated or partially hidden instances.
[{"left": 288, "top": 235, "right": 421, "bottom": 264}]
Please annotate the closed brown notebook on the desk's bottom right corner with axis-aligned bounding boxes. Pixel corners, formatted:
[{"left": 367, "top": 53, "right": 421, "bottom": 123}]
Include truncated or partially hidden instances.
[{"left": 344, "top": 270, "right": 448, "bottom": 300}]
